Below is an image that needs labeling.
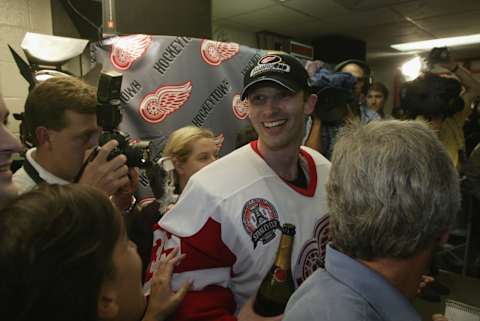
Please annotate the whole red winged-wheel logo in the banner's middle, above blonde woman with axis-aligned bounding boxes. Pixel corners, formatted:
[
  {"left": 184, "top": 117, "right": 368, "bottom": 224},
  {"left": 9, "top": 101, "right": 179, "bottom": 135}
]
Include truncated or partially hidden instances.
[{"left": 139, "top": 81, "right": 192, "bottom": 124}]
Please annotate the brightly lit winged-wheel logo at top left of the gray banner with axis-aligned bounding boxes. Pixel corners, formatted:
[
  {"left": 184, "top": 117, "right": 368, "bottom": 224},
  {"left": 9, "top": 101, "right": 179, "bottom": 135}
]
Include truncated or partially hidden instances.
[{"left": 110, "top": 35, "right": 152, "bottom": 70}]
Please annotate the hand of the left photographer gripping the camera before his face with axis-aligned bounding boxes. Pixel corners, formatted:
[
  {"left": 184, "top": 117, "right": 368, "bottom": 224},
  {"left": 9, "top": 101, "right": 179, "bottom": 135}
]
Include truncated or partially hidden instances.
[{"left": 78, "top": 140, "right": 129, "bottom": 196}]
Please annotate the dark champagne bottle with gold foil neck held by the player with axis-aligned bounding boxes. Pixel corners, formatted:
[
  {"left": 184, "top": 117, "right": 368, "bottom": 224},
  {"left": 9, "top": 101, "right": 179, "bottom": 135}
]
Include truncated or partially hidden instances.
[{"left": 253, "top": 223, "right": 295, "bottom": 317}]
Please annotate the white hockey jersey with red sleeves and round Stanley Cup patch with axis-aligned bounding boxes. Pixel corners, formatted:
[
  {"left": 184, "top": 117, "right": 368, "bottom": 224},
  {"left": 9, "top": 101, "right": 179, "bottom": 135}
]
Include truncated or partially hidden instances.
[{"left": 145, "top": 142, "right": 330, "bottom": 320}]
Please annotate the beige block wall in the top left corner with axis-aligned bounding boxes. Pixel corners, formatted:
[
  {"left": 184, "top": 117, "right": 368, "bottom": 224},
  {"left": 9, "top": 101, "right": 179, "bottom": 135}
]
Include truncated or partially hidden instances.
[{"left": 0, "top": 0, "right": 52, "bottom": 133}]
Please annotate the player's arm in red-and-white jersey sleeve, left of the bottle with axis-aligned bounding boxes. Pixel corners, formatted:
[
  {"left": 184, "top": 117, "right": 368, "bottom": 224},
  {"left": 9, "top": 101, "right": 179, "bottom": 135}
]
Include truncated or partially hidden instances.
[{"left": 145, "top": 218, "right": 236, "bottom": 321}]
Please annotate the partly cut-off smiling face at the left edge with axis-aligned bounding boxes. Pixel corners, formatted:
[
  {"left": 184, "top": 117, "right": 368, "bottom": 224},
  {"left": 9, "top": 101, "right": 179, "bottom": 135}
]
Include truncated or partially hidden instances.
[{"left": 0, "top": 96, "right": 21, "bottom": 202}]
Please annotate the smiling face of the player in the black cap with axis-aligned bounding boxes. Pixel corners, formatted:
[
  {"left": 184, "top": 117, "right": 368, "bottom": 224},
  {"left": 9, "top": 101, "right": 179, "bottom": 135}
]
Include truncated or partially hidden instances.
[{"left": 247, "top": 82, "right": 316, "bottom": 153}]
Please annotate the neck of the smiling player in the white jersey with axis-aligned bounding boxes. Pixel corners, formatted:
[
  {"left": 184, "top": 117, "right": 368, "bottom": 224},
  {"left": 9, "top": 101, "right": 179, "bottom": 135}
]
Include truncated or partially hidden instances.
[{"left": 257, "top": 140, "right": 300, "bottom": 181}]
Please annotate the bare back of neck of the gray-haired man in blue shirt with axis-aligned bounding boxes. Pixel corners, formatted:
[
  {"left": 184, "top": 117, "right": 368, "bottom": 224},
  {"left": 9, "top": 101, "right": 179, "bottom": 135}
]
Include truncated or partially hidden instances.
[{"left": 358, "top": 245, "right": 432, "bottom": 301}]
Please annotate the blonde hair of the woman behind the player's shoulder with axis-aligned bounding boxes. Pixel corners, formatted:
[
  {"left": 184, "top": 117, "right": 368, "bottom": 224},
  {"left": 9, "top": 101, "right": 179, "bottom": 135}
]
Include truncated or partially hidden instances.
[{"left": 162, "top": 126, "right": 215, "bottom": 162}]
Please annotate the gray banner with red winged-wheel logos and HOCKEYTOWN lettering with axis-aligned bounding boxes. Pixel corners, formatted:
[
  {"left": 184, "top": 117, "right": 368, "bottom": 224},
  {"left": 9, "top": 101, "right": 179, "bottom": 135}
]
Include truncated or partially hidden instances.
[{"left": 90, "top": 35, "right": 264, "bottom": 199}]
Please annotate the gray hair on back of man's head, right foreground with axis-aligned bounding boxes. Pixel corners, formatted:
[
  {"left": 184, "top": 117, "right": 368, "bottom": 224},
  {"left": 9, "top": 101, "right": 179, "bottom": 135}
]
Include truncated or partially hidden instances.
[{"left": 327, "top": 120, "right": 460, "bottom": 260}]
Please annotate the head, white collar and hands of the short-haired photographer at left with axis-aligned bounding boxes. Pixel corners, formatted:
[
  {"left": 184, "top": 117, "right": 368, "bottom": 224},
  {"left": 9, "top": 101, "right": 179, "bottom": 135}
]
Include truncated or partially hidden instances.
[{"left": 13, "top": 77, "right": 138, "bottom": 210}]
